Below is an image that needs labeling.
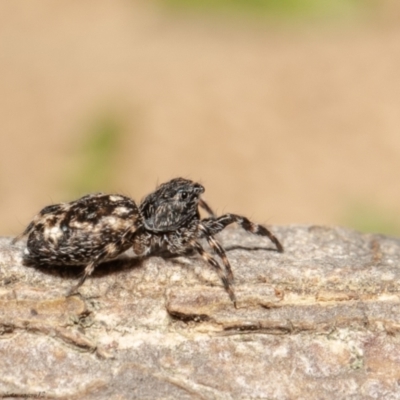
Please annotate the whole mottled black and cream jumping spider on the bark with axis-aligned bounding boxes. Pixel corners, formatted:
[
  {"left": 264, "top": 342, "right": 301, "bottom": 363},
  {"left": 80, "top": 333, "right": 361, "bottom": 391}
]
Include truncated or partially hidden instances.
[{"left": 14, "top": 178, "right": 283, "bottom": 307}]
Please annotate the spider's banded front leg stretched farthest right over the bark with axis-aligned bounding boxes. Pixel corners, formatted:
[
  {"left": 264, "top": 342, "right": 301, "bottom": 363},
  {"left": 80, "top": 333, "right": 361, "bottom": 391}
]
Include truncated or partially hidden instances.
[{"left": 201, "top": 214, "right": 283, "bottom": 253}]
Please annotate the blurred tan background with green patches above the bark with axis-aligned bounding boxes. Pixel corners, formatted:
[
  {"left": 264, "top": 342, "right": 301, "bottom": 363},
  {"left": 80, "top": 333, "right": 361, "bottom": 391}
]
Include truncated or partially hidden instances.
[{"left": 0, "top": 0, "right": 400, "bottom": 235}]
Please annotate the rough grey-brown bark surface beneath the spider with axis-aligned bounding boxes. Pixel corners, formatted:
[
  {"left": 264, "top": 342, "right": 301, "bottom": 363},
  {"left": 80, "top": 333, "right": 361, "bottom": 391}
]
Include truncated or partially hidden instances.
[{"left": 0, "top": 226, "right": 400, "bottom": 400}]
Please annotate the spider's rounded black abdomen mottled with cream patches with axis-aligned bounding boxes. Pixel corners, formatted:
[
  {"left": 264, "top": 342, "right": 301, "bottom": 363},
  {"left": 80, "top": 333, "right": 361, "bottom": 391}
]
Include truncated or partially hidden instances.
[{"left": 24, "top": 193, "right": 141, "bottom": 265}]
